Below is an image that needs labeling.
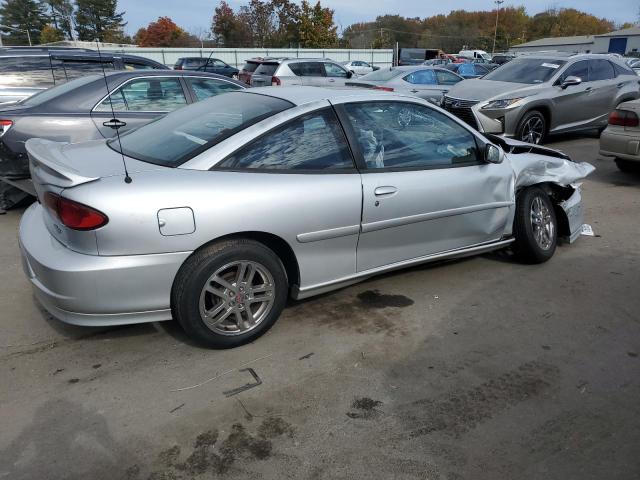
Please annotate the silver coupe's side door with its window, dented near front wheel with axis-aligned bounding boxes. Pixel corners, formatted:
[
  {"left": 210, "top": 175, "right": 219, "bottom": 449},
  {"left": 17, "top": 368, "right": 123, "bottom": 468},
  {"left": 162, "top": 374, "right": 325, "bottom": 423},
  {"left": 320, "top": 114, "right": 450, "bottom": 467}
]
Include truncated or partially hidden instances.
[{"left": 340, "top": 101, "right": 513, "bottom": 272}]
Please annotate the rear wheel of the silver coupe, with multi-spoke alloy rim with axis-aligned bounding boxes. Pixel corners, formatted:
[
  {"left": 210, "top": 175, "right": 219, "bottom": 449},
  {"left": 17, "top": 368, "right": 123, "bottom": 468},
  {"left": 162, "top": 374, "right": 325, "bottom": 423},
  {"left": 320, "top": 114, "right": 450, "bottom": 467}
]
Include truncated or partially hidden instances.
[{"left": 171, "top": 239, "right": 288, "bottom": 348}]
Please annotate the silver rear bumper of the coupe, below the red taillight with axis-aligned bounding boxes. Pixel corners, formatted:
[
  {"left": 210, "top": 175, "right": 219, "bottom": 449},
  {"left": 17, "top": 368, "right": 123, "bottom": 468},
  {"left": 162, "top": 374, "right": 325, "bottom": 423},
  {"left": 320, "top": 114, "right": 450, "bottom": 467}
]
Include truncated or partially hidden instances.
[{"left": 20, "top": 204, "right": 191, "bottom": 326}]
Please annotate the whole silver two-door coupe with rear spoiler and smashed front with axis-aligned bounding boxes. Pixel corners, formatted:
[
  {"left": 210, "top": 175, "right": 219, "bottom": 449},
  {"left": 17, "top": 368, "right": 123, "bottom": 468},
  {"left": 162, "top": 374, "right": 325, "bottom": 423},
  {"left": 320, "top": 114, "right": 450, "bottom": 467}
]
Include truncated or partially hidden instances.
[{"left": 20, "top": 87, "right": 593, "bottom": 348}]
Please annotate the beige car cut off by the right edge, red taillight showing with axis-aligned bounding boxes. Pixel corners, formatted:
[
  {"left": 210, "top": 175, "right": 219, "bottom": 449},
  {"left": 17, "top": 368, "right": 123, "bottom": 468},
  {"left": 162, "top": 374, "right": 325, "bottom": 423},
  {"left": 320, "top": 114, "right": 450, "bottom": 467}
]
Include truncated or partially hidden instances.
[{"left": 600, "top": 100, "right": 640, "bottom": 172}]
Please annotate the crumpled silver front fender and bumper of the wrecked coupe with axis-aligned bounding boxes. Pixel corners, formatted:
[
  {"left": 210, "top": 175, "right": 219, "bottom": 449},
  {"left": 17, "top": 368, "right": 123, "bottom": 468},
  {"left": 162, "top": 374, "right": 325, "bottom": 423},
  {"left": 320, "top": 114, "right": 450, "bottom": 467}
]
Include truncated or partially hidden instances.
[{"left": 488, "top": 135, "right": 595, "bottom": 243}]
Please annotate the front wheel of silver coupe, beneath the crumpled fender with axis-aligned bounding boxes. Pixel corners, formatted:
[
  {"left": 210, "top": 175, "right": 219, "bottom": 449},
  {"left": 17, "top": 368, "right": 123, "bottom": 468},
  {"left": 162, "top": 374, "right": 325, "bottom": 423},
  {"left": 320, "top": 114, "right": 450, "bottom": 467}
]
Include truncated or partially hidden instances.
[{"left": 514, "top": 187, "right": 558, "bottom": 263}]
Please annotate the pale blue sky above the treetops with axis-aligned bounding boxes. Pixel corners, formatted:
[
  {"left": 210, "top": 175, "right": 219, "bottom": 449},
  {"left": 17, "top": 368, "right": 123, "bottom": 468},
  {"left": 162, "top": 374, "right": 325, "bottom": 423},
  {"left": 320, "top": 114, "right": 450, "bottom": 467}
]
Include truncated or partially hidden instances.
[{"left": 118, "top": 0, "right": 640, "bottom": 34}]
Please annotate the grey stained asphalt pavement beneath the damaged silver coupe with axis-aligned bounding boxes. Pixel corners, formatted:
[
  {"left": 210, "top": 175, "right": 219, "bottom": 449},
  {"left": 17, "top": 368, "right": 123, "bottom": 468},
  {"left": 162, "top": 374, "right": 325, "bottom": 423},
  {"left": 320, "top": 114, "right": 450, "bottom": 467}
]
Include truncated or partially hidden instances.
[{"left": 0, "top": 136, "right": 640, "bottom": 480}]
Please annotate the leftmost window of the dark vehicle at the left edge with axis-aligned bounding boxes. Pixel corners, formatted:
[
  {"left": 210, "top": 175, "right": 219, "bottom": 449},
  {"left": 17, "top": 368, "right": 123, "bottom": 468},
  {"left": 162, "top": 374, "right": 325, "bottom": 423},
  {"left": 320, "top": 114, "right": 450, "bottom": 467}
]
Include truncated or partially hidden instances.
[{"left": 0, "top": 56, "right": 54, "bottom": 87}]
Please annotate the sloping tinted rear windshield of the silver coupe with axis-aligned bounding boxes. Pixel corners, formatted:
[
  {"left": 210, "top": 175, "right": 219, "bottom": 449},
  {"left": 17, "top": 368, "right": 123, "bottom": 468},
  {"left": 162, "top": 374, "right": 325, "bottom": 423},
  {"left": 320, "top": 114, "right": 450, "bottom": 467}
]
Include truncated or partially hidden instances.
[{"left": 113, "top": 92, "right": 293, "bottom": 167}]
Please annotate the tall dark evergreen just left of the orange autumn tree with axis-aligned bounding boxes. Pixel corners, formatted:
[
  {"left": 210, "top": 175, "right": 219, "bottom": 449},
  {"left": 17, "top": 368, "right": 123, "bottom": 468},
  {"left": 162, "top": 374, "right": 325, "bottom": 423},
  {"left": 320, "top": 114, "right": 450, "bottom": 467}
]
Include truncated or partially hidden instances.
[{"left": 75, "top": 0, "right": 127, "bottom": 43}]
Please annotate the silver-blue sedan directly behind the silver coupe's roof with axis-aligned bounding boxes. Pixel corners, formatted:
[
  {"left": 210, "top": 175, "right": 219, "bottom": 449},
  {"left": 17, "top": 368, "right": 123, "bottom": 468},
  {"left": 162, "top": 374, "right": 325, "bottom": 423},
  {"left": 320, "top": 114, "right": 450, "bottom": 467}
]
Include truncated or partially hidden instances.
[{"left": 345, "top": 65, "right": 464, "bottom": 105}]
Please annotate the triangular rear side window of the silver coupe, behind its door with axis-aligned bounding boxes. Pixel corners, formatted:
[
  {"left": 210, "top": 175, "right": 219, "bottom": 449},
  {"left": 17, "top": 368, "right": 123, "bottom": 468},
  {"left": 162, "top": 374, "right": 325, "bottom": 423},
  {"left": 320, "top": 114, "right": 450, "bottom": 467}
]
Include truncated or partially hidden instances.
[{"left": 220, "top": 109, "right": 353, "bottom": 170}]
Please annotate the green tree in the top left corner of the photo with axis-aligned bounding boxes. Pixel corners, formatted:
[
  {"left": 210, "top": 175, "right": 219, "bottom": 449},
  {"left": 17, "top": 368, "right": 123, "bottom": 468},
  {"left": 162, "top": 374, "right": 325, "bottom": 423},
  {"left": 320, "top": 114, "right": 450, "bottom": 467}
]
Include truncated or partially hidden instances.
[{"left": 0, "top": 0, "right": 49, "bottom": 45}]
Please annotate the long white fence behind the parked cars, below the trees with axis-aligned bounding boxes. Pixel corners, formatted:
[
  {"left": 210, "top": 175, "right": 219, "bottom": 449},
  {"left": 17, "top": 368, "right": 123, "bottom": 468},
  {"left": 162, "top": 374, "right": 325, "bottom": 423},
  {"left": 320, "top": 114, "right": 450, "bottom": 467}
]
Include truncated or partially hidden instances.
[{"left": 105, "top": 47, "right": 393, "bottom": 68}]
